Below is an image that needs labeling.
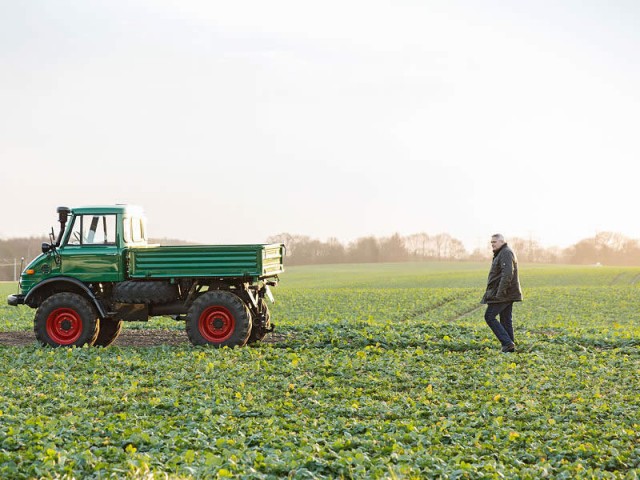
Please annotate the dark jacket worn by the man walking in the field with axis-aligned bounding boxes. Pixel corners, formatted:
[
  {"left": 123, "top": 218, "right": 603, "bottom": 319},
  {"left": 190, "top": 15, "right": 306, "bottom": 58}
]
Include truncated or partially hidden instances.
[{"left": 482, "top": 243, "right": 522, "bottom": 303}]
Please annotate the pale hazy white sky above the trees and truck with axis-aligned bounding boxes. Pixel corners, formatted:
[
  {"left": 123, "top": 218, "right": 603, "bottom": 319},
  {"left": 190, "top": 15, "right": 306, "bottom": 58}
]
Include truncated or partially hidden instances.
[{"left": 0, "top": 0, "right": 640, "bottom": 253}]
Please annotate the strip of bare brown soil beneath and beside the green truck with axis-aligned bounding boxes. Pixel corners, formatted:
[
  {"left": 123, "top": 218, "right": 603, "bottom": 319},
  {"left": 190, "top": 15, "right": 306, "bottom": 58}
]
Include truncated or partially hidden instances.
[{"left": 0, "top": 329, "right": 285, "bottom": 347}]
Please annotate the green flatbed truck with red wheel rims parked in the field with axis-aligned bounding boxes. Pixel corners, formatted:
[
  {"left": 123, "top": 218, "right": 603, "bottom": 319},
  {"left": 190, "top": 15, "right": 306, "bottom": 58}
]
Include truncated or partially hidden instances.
[{"left": 7, "top": 205, "right": 285, "bottom": 347}]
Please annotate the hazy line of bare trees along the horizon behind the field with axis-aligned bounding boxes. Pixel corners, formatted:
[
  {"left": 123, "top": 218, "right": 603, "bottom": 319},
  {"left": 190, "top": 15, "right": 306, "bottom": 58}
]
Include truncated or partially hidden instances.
[{"left": 0, "top": 232, "right": 640, "bottom": 281}]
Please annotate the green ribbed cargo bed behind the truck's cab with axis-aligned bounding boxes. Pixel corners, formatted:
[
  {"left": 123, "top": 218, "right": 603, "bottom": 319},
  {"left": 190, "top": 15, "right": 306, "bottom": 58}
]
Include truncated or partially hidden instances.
[{"left": 128, "top": 245, "right": 284, "bottom": 279}]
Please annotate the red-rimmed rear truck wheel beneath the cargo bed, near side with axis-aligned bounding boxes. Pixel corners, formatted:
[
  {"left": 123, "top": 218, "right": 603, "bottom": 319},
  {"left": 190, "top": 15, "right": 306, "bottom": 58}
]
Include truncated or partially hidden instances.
[{"left": 186, "top": 290, "right": 251, "bottom": 347}]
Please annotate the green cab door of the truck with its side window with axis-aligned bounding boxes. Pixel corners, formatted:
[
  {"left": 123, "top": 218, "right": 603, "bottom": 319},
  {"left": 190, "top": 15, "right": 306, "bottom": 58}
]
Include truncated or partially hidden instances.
[{"left": 59, "top": 214, "right": 122, "bottom": 283}]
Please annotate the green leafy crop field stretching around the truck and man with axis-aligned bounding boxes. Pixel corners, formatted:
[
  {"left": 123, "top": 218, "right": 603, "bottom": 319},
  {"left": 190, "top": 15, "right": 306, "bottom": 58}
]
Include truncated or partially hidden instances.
[{"left": 0, "top": 263, "right": 640, "bottom": 479}]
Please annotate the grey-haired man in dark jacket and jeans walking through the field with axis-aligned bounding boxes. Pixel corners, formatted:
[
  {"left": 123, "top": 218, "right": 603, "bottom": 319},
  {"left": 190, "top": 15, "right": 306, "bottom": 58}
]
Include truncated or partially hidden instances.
[{"left": 482, "top": 233, "right": 522, "bottom": 353}]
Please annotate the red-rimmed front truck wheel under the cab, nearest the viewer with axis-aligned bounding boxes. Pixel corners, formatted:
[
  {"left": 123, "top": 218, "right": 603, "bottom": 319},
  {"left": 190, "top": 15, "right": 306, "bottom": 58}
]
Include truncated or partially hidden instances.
[{"left": 33, "top": 292, "right": 99, "bottom": 347}]
